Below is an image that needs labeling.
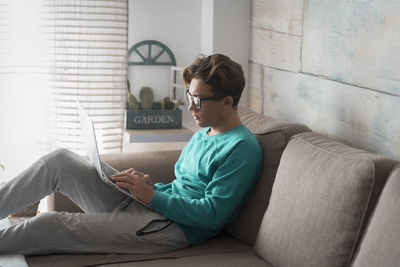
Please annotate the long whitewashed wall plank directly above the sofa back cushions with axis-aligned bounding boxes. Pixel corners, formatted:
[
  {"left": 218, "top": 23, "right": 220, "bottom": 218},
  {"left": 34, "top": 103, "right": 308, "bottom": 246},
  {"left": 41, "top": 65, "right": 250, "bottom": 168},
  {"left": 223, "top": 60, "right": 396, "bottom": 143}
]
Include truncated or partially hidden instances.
[{"left": 263, "top": 67, "right": 400, "bottom": 158}]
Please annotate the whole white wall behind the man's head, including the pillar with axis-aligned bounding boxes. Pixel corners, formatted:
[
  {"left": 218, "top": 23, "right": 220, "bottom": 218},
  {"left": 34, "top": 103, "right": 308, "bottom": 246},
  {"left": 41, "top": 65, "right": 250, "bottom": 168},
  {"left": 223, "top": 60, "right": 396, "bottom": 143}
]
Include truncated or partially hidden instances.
[{"left": 129, "top": 0, "right": 250, "bottom": 130}]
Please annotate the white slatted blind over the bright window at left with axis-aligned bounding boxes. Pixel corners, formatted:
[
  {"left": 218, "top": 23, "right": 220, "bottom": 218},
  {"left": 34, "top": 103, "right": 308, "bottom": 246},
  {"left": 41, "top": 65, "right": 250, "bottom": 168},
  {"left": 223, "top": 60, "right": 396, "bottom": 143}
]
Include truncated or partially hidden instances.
[{"left": 0, "top": 0, "right": 128, "bottom": 180}]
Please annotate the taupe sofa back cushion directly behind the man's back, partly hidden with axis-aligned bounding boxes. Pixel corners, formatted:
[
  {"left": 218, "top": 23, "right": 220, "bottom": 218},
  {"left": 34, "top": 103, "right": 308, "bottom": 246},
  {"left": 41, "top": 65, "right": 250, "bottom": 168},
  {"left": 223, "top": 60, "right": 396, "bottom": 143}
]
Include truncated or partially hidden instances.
[{"left": 225, "top": 108, "right": 310, "bottom": 246}]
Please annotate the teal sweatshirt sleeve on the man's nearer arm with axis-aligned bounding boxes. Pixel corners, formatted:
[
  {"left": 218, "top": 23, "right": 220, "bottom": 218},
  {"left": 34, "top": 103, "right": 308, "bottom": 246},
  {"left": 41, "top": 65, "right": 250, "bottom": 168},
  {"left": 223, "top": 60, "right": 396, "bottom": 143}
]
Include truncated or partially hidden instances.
[{"left": 151, "top": 142, "right": 262, "bottom": 229}]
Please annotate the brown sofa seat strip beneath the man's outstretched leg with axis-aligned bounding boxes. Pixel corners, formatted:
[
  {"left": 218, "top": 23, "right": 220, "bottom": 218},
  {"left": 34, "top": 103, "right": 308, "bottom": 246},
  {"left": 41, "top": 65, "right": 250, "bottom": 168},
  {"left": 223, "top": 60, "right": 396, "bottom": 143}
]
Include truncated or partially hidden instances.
[{"left": 26, "top": 233, "right": 256, "bottom": 267}]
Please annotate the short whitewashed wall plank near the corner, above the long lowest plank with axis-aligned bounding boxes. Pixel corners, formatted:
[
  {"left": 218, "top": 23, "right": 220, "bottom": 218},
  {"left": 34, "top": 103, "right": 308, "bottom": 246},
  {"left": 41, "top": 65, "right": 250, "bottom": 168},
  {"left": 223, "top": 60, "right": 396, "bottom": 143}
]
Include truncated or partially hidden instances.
[{"left": 250, "top": 28, "right": 301, "bottom": 71}]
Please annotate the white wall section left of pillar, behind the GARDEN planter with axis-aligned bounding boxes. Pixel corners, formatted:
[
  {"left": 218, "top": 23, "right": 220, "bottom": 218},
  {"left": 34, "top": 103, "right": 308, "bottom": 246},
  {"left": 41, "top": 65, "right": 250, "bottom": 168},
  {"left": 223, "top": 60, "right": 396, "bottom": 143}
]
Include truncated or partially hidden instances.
[{"left": 128, "top": 0, "right": 201, "bottom": 101}]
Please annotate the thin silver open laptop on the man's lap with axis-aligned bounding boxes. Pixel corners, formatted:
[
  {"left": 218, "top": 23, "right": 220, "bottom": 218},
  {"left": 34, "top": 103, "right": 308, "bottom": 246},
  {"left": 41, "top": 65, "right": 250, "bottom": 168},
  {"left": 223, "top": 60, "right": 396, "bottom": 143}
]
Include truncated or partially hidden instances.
[{"left": 76, "top": 101, "right": 152, "bottom": 209}]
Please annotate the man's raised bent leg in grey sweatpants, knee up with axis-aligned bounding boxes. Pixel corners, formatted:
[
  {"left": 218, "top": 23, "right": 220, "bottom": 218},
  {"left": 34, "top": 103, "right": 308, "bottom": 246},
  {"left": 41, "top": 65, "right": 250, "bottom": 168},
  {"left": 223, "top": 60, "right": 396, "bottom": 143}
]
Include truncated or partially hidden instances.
[{"left": 0, "top": 149, "right": 126, "bottom": 219}]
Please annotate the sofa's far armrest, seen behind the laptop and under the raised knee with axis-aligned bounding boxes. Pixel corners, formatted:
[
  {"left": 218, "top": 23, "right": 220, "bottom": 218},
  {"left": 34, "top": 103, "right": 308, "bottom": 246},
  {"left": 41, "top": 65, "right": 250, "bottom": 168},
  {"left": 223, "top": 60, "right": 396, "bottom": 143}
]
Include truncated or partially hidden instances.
[{"left": 47, "top": 150, "right": 180, "bottom": 212}]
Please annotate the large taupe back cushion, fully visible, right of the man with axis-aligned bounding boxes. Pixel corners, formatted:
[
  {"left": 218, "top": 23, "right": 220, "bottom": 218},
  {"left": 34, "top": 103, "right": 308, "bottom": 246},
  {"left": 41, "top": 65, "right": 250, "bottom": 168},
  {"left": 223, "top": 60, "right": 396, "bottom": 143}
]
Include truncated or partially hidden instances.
[{"left": 255, "top": 133, "right": 398, "bottom": 267}]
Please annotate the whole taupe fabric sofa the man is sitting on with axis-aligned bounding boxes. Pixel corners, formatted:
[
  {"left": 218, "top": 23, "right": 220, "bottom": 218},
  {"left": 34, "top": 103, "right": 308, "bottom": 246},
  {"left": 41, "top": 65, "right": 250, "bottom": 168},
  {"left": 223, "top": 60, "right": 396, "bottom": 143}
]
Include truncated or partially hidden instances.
[{"left": 26, "top": 109, "right": 400, "bottom": 267}]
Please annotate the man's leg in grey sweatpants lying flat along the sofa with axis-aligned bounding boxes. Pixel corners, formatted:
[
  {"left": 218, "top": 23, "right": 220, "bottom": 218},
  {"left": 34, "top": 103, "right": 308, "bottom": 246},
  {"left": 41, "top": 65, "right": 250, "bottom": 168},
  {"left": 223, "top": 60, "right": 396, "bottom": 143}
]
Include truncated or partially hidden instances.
[{"left": 0, "top": 200, "right": 189, "bottom": 255}]
